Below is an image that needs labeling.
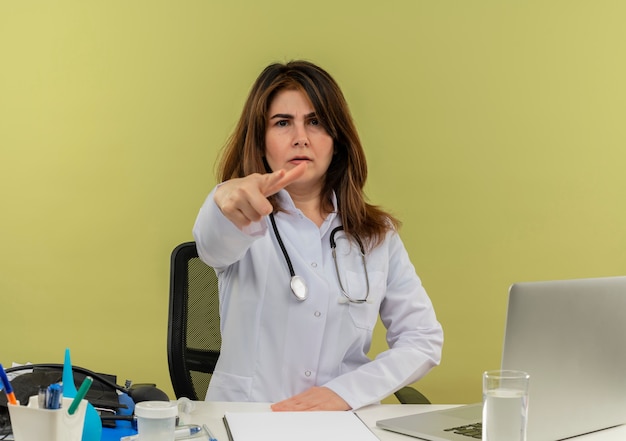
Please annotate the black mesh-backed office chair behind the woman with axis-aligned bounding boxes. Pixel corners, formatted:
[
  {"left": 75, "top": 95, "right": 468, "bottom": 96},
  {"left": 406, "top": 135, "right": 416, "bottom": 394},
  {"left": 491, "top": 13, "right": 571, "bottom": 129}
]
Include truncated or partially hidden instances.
[{"left": 167, "top": 242, "right": 430, "bottom": 404}]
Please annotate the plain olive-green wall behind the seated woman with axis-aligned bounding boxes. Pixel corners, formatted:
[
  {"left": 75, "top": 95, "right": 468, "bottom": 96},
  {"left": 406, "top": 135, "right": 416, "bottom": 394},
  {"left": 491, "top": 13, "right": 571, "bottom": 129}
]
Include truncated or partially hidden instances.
[{"left": 0, "top": 0, "right": 626, "bottom": 403}]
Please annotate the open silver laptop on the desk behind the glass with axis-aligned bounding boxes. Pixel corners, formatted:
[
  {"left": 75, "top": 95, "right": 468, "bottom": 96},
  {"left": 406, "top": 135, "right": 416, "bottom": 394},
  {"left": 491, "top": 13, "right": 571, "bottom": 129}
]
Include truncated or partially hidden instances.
[{"left": 376, "top": 277, "right": 626, "bottom": 441}]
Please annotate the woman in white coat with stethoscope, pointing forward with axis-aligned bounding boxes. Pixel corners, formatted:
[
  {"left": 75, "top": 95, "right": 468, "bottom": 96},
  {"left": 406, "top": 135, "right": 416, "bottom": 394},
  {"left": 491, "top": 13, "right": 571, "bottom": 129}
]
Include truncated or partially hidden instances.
[{"left": 193, "top": 61, "right": 443, "bottom": 411}]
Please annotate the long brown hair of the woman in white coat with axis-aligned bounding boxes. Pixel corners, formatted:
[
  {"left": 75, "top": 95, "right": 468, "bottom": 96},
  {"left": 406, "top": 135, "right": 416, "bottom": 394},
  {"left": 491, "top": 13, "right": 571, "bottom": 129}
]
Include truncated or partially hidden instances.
[{"left": 217, "top": 60, "right": 400, "bottom": 248}]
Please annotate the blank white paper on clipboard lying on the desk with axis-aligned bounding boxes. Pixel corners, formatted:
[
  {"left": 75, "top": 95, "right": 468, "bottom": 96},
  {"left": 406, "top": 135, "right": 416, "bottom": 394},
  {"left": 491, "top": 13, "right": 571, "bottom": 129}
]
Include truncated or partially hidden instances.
[{"left": 224, "top": 411, "right": 379, "bottom": 441}]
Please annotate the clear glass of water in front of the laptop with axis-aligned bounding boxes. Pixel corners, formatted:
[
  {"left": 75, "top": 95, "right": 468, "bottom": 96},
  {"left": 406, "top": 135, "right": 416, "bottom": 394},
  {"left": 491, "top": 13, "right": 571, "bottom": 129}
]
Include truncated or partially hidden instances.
[{"left": 482, "top": 370, "right": 530, "bottom": 441}]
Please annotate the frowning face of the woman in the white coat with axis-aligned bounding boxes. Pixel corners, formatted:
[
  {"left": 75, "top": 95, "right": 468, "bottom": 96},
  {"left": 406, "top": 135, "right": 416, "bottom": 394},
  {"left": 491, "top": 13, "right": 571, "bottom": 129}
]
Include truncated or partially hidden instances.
[{"left": 265, "top": 90, "right": 333, "bottom": 192}]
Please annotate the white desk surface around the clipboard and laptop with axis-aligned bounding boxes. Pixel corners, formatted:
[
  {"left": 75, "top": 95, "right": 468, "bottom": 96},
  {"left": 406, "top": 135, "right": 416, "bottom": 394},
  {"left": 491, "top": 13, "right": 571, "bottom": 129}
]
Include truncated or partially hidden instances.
[{"left": 184, "top": 401, "right": 626, "bottom": 441}]
